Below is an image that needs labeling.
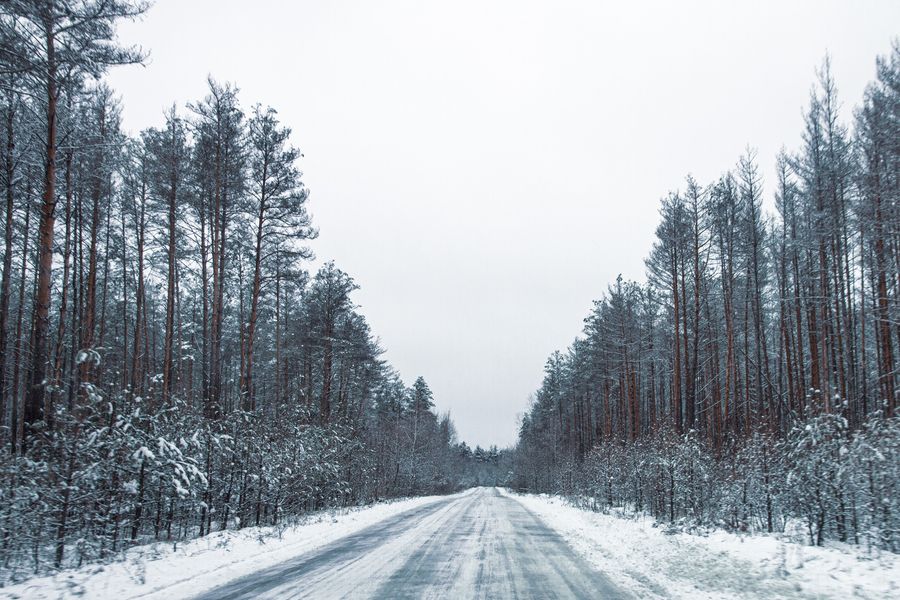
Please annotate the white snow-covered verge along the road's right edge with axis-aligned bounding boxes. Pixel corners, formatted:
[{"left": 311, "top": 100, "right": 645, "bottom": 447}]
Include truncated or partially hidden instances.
[{"left": 504, "top": 491, "right": 900, "bottom": 599}]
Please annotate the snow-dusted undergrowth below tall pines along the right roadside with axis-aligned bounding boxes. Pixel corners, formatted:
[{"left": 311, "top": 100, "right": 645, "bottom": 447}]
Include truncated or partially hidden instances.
[{"left": 520, "top": 413, "right": 900, "bottom": 551}]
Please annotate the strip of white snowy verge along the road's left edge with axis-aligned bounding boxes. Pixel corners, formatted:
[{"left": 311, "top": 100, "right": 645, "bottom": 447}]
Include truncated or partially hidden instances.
[{"left": 0, "top": 492, "right": 454, "bottom": 600}]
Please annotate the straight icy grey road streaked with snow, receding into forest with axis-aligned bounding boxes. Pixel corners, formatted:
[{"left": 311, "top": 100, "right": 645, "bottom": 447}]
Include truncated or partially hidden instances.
[{"left": 192, "top": 488, "right": 628, "bottom": 600}]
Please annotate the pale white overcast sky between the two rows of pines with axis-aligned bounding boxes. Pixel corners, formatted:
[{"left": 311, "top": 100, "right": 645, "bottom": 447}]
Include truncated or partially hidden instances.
[{"left": 110, "top": 0, "right": 900, "bottom": 445}]
